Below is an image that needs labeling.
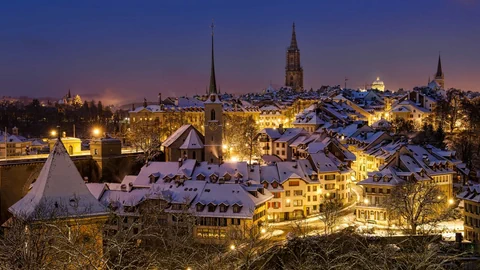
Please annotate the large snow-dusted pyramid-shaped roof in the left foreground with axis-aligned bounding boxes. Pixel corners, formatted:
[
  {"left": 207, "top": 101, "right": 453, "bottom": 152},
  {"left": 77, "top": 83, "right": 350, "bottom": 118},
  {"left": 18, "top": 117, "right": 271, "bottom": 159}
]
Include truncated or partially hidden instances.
[{"left": 8, "top": 140, "right": 108, "bottom": 220}]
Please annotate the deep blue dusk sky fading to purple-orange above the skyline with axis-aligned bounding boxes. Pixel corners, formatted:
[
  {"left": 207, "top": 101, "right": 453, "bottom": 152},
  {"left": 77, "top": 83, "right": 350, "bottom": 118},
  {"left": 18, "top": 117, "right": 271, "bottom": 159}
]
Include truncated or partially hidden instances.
[{"left": 0, "top": 0, "right": 480, "bottom": 102}]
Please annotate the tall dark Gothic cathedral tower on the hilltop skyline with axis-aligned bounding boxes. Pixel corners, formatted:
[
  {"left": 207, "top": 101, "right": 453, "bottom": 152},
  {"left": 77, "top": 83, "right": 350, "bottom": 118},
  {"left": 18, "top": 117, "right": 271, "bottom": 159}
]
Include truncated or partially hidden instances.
[{"left": 285, "top": 23, "right": 303, "bottom": 91}]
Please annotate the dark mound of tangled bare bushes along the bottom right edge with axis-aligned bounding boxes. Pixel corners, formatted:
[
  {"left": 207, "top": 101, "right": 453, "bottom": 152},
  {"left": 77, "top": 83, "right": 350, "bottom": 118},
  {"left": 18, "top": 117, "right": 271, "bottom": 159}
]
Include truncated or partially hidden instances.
[{"left": 251, "top": 230, "right": 464, "bottom": 270}]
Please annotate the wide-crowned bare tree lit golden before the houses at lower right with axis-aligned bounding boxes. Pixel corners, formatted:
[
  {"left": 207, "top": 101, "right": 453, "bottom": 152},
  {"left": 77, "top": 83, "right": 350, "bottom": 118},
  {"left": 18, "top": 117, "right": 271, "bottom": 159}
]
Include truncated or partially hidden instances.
[{"left": 385, "top": 181, "right": 452, "bottom": 235}]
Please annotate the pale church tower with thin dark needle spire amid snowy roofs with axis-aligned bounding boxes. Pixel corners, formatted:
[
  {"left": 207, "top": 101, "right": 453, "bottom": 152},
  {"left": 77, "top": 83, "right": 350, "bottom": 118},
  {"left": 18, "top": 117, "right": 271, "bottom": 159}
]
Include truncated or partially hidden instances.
[{"left": 205, "top": 20, "right": 223, "bottom": 164}]
